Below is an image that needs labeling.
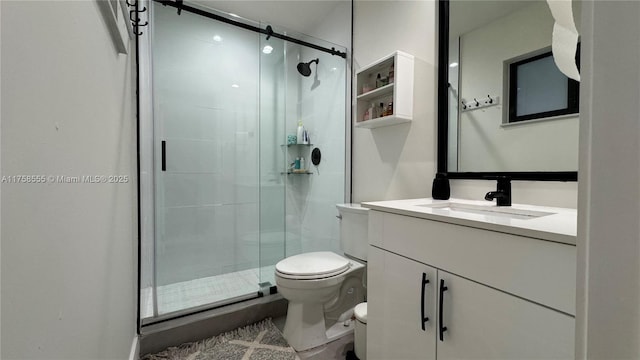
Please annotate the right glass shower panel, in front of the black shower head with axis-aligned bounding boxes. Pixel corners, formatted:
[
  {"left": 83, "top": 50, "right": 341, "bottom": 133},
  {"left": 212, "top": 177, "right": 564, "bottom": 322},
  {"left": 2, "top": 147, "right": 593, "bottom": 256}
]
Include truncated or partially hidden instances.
[{"left": 260, "top": 29, "right": 347, "bottom": 288}]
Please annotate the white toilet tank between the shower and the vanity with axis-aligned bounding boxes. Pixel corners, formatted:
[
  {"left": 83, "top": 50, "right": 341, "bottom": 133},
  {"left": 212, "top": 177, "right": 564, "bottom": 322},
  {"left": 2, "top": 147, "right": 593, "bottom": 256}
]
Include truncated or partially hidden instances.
[{"left": 336, "top": 204, "right": 369, "bottom": 261}]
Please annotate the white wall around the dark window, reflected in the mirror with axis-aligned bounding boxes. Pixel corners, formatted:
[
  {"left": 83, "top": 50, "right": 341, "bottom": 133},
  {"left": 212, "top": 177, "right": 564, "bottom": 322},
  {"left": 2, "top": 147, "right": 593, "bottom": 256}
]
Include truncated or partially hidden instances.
[{"left": 458, "top": 2, "right": 578, "bottom": 171}]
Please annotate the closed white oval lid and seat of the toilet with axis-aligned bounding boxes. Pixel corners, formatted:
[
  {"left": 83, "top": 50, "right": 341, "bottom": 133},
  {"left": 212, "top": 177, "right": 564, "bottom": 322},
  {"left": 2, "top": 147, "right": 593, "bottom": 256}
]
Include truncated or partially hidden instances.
[{"left": 276, "top": 251, "right": 349, "bottom": 279}]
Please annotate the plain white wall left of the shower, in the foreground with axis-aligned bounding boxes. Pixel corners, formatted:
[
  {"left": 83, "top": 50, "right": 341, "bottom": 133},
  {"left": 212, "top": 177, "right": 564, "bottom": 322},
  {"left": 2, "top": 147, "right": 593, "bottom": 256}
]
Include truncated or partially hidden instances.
[{"left": 0, "top": 1, "right": 137, "bottom": 359}]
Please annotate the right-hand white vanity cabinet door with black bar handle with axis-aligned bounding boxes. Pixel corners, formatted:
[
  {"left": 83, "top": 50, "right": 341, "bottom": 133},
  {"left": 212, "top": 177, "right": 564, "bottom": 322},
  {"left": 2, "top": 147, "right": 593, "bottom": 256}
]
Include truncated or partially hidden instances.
[{"left": 437, "top": 270, "right": 575, "bottom": 360}]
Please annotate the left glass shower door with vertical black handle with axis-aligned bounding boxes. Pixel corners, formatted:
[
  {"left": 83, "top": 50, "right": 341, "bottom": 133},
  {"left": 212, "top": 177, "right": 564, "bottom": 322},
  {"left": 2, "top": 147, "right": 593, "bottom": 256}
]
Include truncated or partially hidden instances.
[{"left": 152, "top": 3, "right": 260, "bottom": 315}]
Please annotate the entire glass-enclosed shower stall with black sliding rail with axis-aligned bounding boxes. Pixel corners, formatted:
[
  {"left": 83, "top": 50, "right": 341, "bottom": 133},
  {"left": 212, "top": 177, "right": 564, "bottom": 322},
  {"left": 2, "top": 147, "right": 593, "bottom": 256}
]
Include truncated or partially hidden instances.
[{"left": 139, "top": 1, "right": 349, "bottom": 325}]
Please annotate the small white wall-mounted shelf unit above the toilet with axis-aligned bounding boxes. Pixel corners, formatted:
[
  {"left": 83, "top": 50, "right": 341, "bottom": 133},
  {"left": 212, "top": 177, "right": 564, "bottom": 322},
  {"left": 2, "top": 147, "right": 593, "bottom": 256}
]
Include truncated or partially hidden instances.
[{"left": 354, "top": 51, "right": 414, "bottom": 129}]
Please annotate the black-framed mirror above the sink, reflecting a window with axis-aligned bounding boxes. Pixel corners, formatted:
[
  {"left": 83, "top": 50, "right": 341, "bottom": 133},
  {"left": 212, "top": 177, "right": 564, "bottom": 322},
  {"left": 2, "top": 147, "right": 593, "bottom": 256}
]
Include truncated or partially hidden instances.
[{"left": 438, "top": 0, "right": 579, "bottom": 181}]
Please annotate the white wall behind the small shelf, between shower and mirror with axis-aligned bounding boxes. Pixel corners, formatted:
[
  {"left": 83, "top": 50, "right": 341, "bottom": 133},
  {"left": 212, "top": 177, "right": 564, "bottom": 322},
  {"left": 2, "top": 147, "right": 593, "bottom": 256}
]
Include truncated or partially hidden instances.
[{"left": 352, "top": 0, "right": 437, "bottom": 202}]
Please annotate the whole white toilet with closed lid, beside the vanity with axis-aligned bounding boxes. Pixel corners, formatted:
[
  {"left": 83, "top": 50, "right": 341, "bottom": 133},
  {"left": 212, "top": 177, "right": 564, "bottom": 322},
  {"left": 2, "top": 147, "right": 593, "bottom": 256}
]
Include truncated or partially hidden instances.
[{"left": 275, "top": 204, "right": 369, "bottom": 351}]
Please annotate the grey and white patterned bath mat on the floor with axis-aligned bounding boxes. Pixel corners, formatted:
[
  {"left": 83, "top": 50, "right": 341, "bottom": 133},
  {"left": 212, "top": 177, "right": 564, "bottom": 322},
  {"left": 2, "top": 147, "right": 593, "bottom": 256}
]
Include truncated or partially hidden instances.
[{"left": 141, "top": 319, "right": 299, "bottom": 360}]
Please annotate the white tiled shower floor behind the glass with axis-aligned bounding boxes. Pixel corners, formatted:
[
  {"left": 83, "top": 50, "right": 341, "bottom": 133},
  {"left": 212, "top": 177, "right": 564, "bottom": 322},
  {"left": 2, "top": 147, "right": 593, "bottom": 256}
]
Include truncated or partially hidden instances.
[{"left": 140, "top": 265, "right": 275, "bottom": 319}]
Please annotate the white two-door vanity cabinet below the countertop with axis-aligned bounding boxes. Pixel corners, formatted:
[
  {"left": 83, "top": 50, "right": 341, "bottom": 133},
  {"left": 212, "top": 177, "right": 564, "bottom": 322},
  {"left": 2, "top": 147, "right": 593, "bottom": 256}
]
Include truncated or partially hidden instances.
[{"left": 367, "top": 211, "right": 575, "bottom": 360}]
